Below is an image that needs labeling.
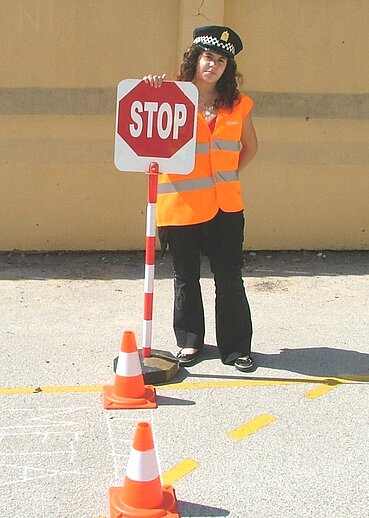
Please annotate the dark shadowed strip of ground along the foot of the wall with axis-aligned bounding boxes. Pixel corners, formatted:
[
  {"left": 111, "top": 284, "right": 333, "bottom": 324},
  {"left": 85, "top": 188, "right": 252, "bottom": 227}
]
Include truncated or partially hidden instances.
[{"left": 0, "top": 251, "right": 369, "bottom": 280}]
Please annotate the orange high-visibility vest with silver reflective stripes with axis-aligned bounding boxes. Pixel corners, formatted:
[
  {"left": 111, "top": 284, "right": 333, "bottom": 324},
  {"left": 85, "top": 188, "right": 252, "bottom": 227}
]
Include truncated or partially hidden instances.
[{"left": 157, "top": 95, "right": 253, "bottom": 227}]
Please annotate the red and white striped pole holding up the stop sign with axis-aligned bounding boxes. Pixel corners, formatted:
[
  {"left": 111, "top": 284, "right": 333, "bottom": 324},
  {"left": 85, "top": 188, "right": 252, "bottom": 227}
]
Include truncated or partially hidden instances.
[{"left": 142, "top": 162, "right": 159, "bottom": 358}]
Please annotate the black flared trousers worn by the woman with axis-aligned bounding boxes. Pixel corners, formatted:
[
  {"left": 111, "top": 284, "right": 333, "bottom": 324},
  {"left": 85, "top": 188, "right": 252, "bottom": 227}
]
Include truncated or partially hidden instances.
[{"left": 159, "top": 211, "right": 252, "bottom": 364}]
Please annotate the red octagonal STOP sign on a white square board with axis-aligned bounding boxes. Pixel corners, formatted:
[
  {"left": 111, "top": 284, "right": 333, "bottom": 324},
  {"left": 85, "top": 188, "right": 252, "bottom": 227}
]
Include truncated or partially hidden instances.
[{"left": 115, "top": 79, "right": 198, "bottom": 174}]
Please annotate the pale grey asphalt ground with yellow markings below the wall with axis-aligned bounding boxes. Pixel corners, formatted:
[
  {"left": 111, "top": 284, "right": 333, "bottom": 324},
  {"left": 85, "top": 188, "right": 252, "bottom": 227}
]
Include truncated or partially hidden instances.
[{"left": 0, "top": 251, "right": 369, "bottom": 518}]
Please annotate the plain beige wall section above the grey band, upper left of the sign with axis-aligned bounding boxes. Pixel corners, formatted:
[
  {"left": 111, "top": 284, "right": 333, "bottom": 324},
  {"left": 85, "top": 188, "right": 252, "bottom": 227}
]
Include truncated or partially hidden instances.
[{"left": 0, "top": 0, "right": 180, "bottom": 88}]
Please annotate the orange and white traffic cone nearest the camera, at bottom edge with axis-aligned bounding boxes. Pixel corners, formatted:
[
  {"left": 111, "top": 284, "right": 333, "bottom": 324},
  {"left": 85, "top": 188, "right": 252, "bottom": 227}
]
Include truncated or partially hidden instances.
[{"left": 109, "top": 422, "right": 180, "bottom": 518}]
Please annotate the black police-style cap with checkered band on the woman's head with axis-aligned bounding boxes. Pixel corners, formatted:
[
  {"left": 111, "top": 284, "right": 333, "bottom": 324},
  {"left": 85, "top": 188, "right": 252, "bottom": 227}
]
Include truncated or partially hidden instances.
[{"left": 193, "top": 25, "right": 243, "bottom": 58}]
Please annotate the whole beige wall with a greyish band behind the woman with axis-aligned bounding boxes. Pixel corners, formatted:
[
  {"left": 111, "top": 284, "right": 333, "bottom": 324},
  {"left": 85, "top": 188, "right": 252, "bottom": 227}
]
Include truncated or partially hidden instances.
[{"left": 0, "top": 0, "right": 369, "bottom": 250}]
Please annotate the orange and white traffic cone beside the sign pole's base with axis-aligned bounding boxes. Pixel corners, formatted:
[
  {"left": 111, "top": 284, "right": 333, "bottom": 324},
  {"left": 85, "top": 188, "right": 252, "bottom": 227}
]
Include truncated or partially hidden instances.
[{"left": 103, "top": 331, "right": 157, "bottom": 410}]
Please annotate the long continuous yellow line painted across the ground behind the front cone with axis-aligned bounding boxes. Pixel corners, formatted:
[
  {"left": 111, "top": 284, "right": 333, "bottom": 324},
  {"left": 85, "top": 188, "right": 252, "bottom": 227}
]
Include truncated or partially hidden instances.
[{"left": 0, "top": 376, "right": 369, "bottom": 395}]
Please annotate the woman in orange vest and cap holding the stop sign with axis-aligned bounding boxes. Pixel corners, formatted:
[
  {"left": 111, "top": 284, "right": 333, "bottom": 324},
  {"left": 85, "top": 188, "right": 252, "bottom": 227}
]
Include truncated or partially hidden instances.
[{"left": 143, "top": 26, "right": 257, "bottom": 372}]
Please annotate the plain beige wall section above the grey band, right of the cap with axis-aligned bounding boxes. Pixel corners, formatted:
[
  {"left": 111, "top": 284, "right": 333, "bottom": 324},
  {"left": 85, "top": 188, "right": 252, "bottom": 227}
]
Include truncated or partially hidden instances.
[{"left": 229, "top": 0, "right": 369, "bottom": 94}]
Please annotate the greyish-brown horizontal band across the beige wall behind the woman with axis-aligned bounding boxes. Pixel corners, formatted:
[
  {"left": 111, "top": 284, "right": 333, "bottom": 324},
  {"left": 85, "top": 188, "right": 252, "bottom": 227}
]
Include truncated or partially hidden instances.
[{"left": 0, "top": 87, "right": 369, "bottom": 120}]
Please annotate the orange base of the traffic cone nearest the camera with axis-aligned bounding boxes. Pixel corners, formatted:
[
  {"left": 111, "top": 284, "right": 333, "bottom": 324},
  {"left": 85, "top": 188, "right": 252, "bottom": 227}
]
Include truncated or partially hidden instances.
[{"left": 109, "top": 486, "right": 180, "bottom": 518}]
